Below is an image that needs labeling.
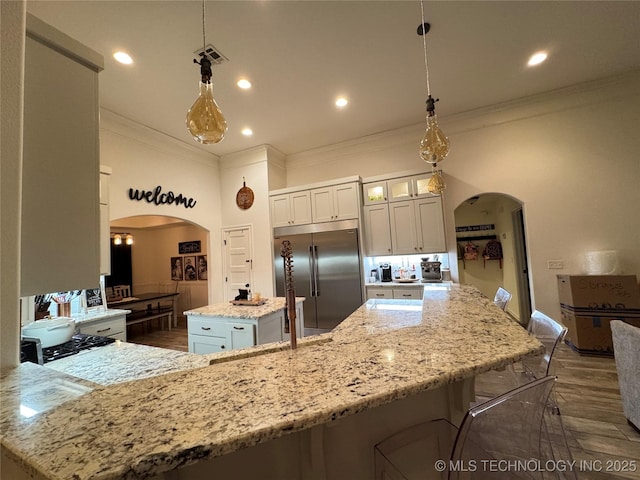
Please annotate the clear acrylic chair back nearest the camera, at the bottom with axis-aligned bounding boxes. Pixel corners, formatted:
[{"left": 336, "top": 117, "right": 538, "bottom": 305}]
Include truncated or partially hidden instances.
[{"left": 449, "top": 376, "right": 556, "bottom": 480}]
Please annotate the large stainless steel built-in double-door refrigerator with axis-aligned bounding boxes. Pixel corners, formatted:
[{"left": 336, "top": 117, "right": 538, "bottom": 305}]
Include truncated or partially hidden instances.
[{"left": 274, "top": 220, "right": 362, "bottom": 333}]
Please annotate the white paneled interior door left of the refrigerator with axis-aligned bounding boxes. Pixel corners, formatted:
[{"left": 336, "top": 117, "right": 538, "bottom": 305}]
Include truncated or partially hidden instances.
[{"left": 223, "top": 225, "right": 253, "bottom": 300}]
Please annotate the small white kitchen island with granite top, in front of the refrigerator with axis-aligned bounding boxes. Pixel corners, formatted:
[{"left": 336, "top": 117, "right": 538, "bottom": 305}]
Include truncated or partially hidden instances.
[{"left": 184, "top": 297, "right": 304, "bottom": 354}]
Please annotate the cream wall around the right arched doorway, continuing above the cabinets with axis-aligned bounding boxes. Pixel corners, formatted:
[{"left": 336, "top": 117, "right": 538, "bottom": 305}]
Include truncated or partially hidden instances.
[{"left": 287, "top": 71, "right": 640, "bottom": 318}]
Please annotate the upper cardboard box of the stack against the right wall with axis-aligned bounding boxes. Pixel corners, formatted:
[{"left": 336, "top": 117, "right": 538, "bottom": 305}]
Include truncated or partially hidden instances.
[{"left": 558, "top": 275, "right": 640, "bottom": 310}]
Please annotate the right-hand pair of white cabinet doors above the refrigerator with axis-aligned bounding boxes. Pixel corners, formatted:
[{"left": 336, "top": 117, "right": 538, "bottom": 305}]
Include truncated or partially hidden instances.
[{"left": 310, "top": 183, "right": 360, "bottom": 223}]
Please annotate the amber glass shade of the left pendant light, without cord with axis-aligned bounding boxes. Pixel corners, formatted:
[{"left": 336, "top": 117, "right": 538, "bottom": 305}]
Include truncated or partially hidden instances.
[{"left": 187, "top": 82, "right": 227, "bottom": 144}]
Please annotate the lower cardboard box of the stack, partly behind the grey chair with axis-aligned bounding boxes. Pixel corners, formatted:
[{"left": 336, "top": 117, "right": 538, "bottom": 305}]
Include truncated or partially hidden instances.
[{"left": 560, "top": 307, "right": 640, "bottom": 355}]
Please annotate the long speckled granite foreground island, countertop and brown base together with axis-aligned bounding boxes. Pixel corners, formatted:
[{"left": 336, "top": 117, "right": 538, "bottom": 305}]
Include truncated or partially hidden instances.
[{"left": 1, "top": 286, "right": 543, "bottom": 480}]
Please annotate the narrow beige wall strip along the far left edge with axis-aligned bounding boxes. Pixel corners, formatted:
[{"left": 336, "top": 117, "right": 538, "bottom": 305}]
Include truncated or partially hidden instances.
[{"left": 0, "top": 1, "right": 26, "bottom": 368}]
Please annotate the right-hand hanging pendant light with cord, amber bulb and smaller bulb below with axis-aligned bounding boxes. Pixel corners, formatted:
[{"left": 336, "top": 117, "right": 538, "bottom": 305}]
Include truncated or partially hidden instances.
[{"left": 418, "top": 0, "right": 449, "bottom": 195}]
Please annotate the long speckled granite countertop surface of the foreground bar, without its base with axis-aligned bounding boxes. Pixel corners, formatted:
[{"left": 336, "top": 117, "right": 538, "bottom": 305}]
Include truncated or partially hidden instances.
[{"left": 0, "top": 286, "right": 543, "bottom": 480}]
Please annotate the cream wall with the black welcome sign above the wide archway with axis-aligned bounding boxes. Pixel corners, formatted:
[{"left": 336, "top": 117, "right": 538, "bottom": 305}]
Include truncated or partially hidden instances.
[{"left": 100, "top": 110, "right": 222, "bottom": 302}]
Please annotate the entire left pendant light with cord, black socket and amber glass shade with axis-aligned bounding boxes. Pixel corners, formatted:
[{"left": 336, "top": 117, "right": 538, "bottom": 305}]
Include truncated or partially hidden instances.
[{"left": 187, "top": 0, "right": 227, "bottom": 144}]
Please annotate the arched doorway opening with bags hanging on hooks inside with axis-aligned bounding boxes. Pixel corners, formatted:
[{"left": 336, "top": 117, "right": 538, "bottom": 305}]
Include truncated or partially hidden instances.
[{"left": 454, "top": 193, "right": 531, "bottom": 325}]
